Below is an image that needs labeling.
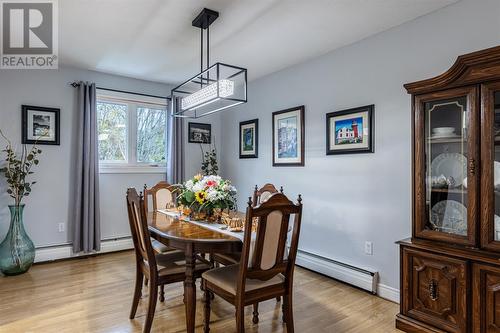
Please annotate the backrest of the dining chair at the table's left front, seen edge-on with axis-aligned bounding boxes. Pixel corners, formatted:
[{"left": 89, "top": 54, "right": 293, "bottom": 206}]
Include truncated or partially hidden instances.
[{"left": 127, "top": 188, "right": 156, "bottom": 269}]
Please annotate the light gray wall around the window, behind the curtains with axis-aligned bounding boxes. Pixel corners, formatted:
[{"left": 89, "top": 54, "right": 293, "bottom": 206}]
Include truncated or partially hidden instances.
[{"left": 0, "top": 68, "right": 220, "bottom": 247}]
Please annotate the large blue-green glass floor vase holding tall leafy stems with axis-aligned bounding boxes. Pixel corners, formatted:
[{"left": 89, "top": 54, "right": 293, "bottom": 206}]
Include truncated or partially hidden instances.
[{"left": 0, "top": 205, "right": 35, "bottom": 275}]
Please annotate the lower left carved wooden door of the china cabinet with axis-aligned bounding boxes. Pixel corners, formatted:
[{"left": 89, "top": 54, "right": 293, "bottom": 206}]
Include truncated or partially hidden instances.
[{"left": 402, "top": 248, "right": 468, "bottom": 332}]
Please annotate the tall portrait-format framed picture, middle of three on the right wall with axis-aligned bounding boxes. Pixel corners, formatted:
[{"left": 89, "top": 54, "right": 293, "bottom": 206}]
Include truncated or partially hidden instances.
[{"left": 273, "top": 105, "right": 305, "bottom": 166}]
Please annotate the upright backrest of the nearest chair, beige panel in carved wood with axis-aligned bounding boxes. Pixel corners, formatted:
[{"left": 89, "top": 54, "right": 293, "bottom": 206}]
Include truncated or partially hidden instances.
[{"left": 238, "top": 193, "right": 302, "bottom": 291}]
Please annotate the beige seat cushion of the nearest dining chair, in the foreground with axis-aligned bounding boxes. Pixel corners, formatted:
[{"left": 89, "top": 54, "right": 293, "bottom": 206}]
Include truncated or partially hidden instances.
[{"left": 201, "top": 264, "right": 285, "bottom": 295}]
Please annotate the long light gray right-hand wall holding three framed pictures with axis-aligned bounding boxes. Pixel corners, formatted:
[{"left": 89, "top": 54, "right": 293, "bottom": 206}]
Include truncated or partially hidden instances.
[{"left": 222, "top": 0, "right": 500, "bottom": 288}]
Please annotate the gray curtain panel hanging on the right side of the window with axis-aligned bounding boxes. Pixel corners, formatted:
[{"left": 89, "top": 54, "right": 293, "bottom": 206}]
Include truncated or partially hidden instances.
[{"left": 167, "top": 97, "right": 185, "bottom": 184}]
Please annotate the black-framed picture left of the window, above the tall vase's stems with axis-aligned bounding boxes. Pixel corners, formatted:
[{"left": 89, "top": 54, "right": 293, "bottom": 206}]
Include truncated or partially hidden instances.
[{"left": 22, "top": 105, "right": 60, "bottom": 145}]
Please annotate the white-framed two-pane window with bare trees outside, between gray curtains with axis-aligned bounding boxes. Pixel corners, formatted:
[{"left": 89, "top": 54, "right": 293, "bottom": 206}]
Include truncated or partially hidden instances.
[{"left": 97, "top": 90, "right": 167, "bottom": 173}]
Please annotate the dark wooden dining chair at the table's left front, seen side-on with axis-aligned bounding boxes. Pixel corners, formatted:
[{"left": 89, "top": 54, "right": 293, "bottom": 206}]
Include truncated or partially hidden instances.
[{"left": 126, "top": 188, "right": 210, "bottom": 333}]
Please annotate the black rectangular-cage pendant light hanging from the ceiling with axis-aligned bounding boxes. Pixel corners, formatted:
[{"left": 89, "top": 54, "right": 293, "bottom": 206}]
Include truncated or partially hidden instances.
[{"left": 171, "top": 8, "right": 247, "bottom": 119}]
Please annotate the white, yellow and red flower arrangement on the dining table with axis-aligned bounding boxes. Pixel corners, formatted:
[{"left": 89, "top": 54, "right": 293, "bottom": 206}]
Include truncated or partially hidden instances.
[{"left": 177, "top": 174, "right": 236, "bottom": 216}]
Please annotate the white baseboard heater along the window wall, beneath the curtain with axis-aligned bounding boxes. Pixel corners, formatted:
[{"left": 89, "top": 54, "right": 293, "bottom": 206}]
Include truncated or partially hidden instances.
[{"left": 35, "top": 238, "right": 134, "bottom": 262}]
